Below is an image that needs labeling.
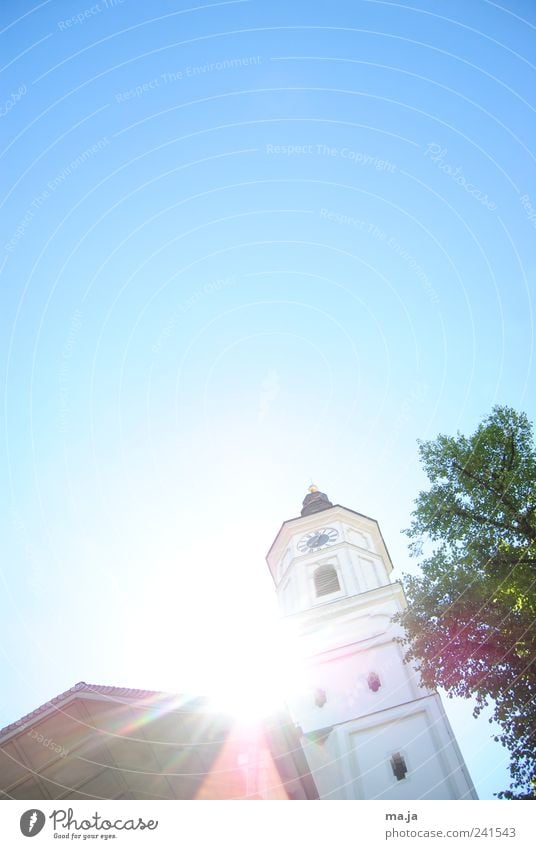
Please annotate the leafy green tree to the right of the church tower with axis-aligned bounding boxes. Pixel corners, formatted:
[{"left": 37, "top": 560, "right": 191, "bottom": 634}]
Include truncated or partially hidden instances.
[{"left": 398, "top": 407, "right": 536, "bottom": 799}]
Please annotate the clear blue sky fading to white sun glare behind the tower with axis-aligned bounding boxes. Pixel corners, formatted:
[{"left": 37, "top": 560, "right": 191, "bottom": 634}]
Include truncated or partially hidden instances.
[{"left": 0, "top": 0, "right": 536, "bottom": 798}]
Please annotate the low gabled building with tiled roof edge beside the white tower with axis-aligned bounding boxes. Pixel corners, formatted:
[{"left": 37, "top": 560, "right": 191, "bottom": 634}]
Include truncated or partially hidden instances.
[{"left": 0, "top": 681, "right": 318, "bottom": 799}]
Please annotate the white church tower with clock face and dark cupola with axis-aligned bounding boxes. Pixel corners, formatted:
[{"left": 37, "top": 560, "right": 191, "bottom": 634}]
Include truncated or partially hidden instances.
[{"left": 267, "top": 486, "right": 477, "bottom": 800}]
